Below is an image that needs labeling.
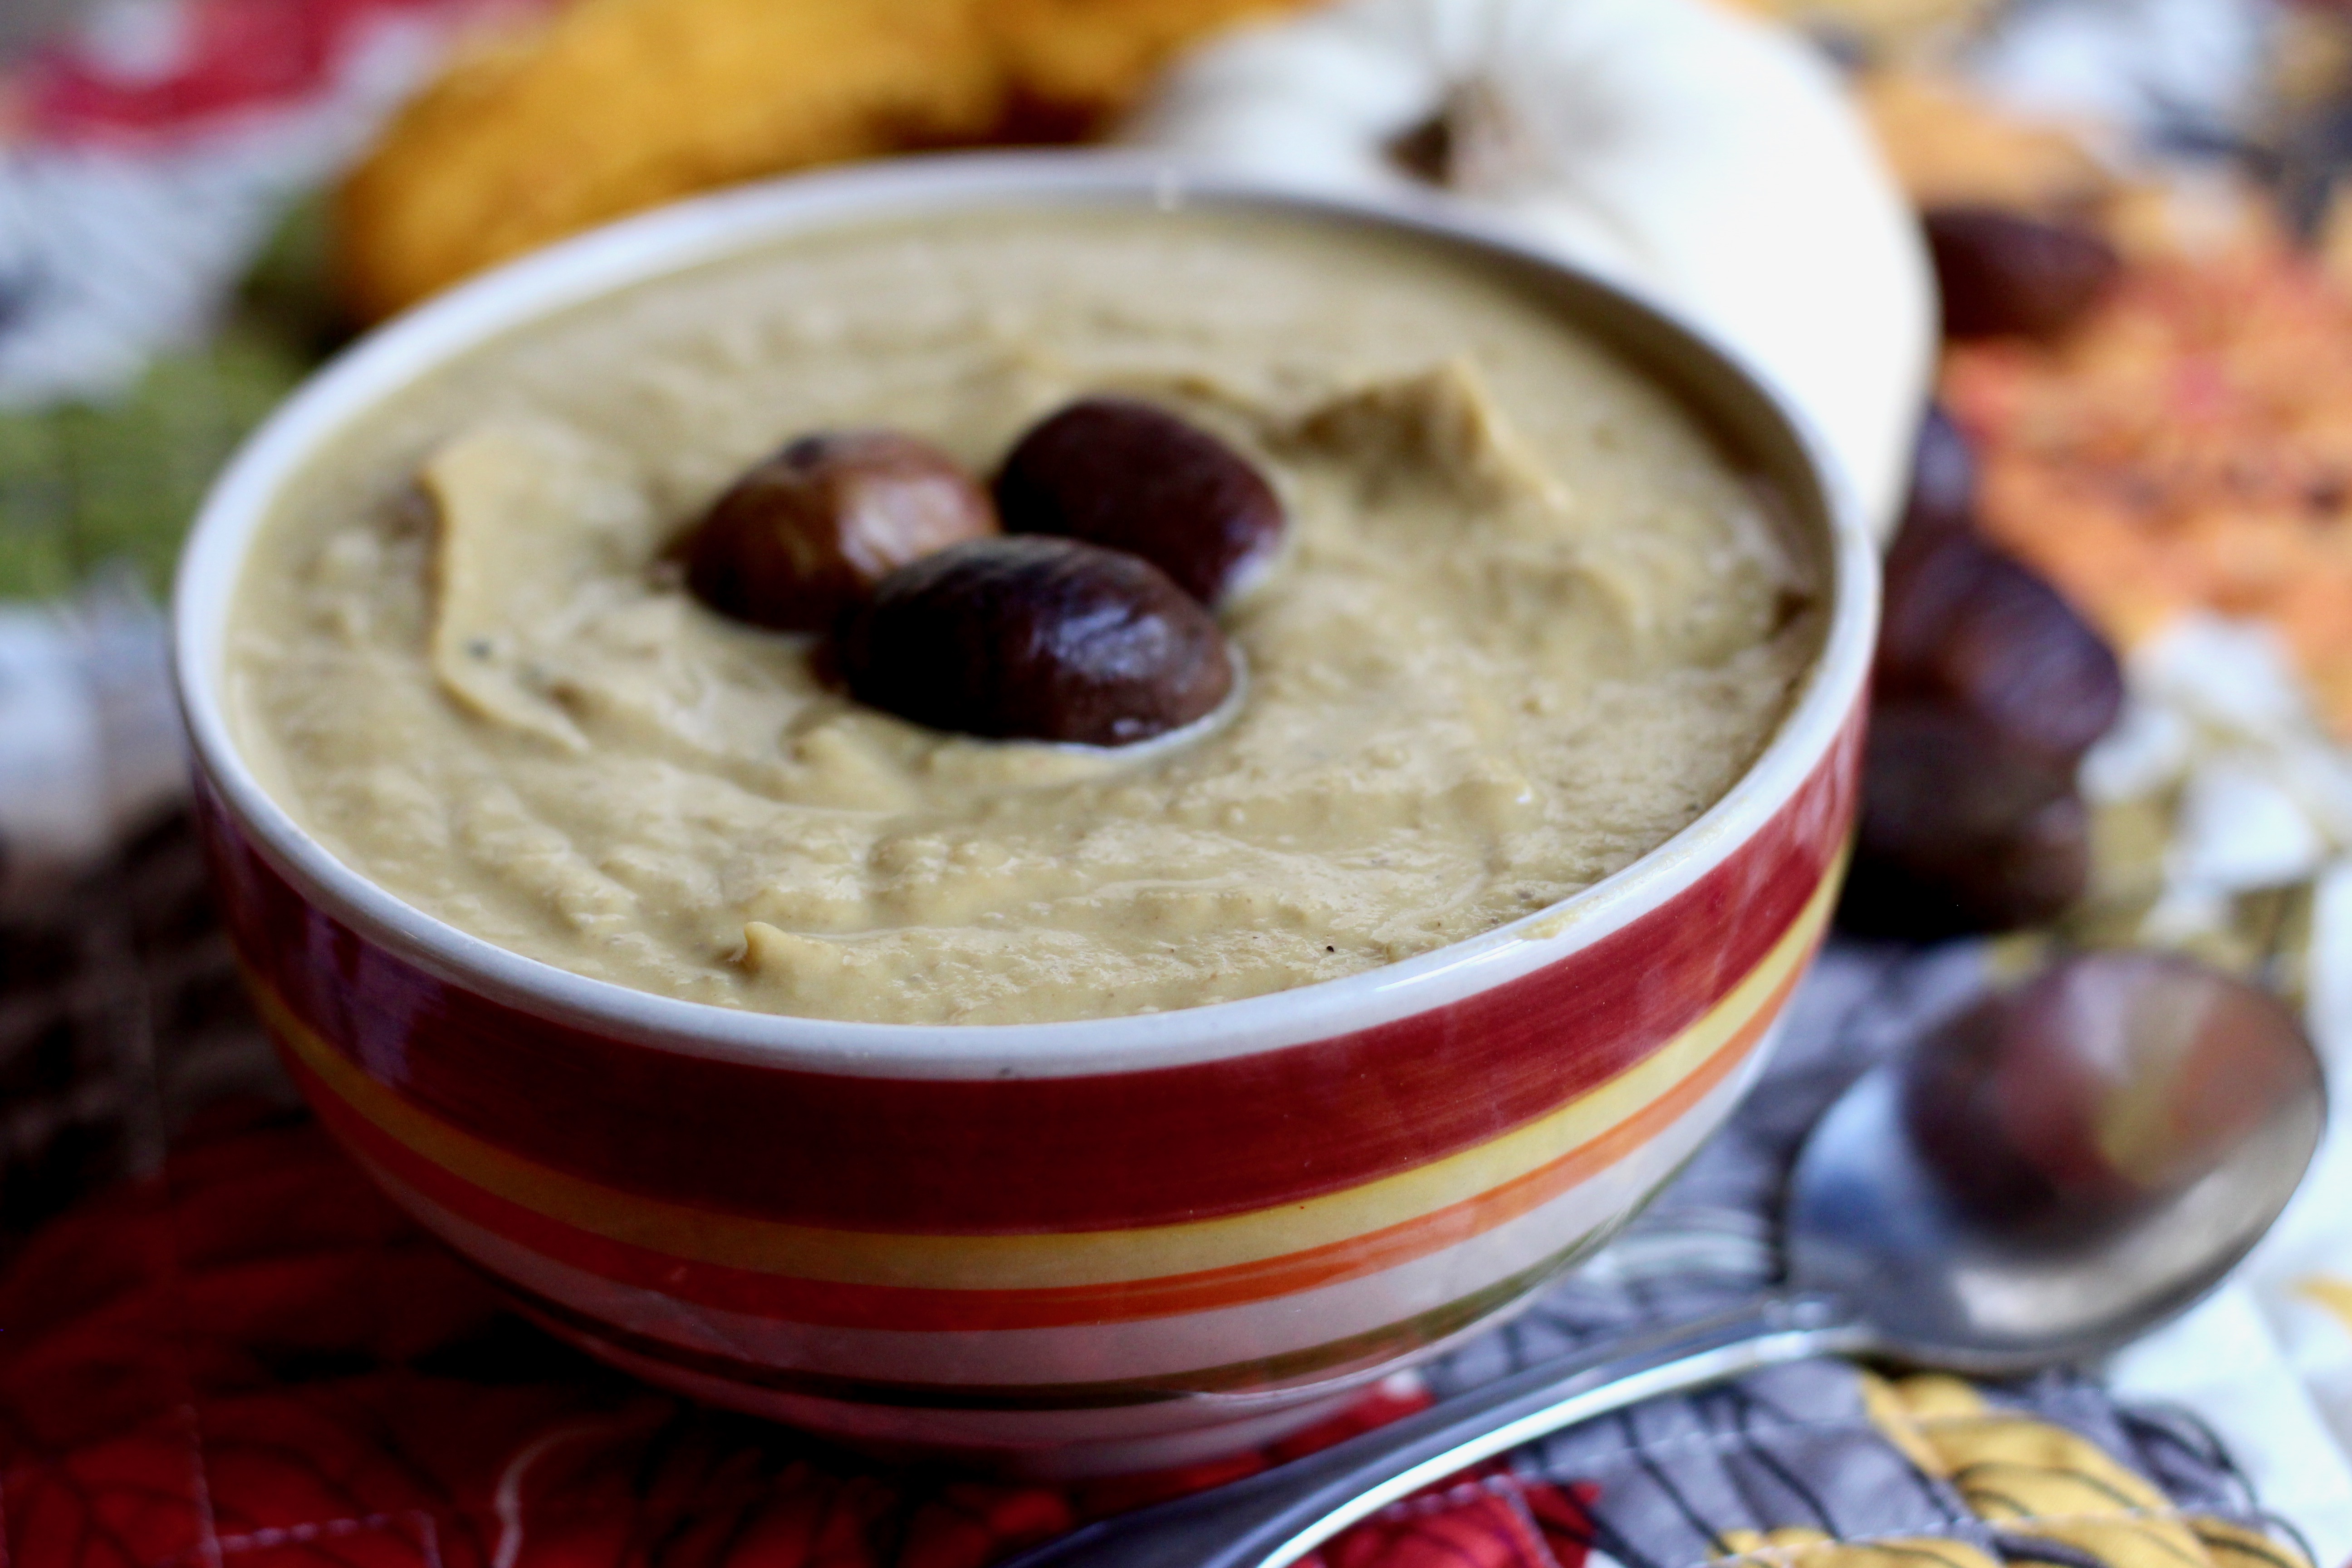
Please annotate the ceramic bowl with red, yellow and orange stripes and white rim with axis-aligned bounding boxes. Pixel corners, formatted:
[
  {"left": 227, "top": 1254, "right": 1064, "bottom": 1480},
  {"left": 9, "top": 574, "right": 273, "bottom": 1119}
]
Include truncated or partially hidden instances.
[{"left": 176, "top": 155, "right": 1877, "bottom": 1469}]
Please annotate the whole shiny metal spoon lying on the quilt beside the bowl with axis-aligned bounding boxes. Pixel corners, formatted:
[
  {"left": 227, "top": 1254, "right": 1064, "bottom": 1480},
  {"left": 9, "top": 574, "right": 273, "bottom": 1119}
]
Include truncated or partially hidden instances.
[{"left": 1007, "top": 955, "right": 2326, "bottom": 1568}]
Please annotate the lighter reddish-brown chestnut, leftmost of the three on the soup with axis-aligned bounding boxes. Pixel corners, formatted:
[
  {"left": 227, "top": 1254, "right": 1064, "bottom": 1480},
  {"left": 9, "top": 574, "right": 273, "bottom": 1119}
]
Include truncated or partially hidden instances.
[{"left": 685, "top": 430, "right": 997, "bottom": 632}]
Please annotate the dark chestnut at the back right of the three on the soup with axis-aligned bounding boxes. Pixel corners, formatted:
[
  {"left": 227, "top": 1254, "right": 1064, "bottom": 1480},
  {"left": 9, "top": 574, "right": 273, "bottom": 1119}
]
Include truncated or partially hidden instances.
[{"left": 997, "top": 397, "right": 1284, "bottom": 604}]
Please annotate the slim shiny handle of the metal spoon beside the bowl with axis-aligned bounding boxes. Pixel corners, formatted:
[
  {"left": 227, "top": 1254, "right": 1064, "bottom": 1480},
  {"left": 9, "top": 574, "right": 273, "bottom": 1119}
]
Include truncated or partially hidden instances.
[{"left": 1004, "top": 1295, "right": 1870, "bottom": 1568}]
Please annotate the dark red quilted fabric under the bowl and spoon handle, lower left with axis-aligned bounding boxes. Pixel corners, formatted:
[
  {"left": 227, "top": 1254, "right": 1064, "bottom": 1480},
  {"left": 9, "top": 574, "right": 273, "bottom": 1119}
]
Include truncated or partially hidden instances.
[{"left": 0, "top": 1124, "right": 1585, "bottom": 1568}]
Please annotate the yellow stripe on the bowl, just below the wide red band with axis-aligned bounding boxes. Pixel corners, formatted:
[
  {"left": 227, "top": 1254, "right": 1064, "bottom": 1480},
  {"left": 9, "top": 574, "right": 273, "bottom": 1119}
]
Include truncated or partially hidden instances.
[{"left": 270, "top": 865, "right": 1839, "bottom": 1291}]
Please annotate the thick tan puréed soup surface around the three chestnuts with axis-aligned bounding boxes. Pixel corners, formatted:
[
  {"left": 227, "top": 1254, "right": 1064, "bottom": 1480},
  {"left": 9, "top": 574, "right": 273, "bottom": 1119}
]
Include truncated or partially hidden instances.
[{"left": 228, "top": 209, "right": 1823, "bottom": 1023}]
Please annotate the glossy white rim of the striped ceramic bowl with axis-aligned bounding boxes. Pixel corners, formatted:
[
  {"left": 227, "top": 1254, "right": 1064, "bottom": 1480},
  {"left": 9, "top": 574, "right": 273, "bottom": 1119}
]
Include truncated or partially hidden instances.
[{"left": 172, "top": 151, "right": 1879, "bottom": 1079}]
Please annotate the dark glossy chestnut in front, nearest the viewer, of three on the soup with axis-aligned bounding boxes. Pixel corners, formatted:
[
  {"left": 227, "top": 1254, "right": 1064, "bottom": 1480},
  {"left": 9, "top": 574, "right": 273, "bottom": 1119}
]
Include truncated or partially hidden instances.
[{"left": 838, "top": 536, "right": 1232, "bottom": 745}]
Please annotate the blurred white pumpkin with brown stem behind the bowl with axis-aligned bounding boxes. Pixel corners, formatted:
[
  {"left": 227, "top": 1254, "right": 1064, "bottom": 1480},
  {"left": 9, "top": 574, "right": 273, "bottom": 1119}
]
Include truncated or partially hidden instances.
[{"left": 1122, "top": 0, "right": 1936, "bottom": 534}]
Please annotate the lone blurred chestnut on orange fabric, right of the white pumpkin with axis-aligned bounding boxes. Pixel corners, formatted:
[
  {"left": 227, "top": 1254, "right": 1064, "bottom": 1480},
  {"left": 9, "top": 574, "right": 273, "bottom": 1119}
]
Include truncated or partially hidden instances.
[{"left": 1926, "top": 207, "right": 2122, "bottom": 338}]
